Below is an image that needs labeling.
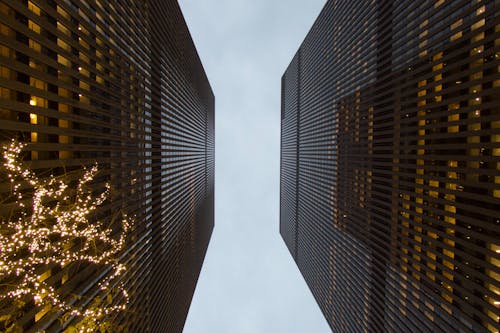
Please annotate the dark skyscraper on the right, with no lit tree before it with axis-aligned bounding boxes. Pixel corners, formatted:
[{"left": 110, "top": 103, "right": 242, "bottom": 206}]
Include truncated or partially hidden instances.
[{"left": 280, "top": 0, "right": 500, "bottom": 332}]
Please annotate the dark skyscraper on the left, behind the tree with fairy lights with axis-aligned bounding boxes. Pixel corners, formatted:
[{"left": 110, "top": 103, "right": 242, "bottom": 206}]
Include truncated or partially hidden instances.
[{"left": 0, "top": 0, "right": 215, "bottom": 332}]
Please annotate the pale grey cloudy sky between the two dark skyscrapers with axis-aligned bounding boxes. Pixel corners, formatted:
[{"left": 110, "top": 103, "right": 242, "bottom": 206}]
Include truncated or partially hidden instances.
[{"left": 179, "top": 0, "right": 330, "bottom": 333}]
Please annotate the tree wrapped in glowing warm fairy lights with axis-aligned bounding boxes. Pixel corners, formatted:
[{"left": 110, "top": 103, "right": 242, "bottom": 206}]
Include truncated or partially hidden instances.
[{"left": 0, "top": 140, "right": 131, "bottom": 332}]
